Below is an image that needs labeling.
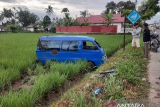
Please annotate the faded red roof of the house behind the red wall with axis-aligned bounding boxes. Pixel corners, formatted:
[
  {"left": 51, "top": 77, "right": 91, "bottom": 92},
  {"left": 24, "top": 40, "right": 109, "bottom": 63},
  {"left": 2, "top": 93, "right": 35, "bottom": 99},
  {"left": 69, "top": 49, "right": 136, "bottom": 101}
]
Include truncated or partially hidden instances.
[{"left": 76, "top": 14, "right": 124, "bottom": 24}]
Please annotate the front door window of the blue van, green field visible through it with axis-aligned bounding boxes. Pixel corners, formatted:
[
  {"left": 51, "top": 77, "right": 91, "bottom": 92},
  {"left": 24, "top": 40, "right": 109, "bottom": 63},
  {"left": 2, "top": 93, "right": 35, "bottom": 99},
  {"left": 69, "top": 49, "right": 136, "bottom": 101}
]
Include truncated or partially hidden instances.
[{"left": 83, "top": 41, "right": 98, "bottom": 50}]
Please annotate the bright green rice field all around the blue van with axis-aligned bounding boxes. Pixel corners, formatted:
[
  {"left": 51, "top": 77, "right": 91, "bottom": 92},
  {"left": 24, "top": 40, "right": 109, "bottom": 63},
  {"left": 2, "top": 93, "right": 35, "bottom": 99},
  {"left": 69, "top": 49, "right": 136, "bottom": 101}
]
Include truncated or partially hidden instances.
[{"left": 0, "top": 33, "right": 131, "bottom": 107}]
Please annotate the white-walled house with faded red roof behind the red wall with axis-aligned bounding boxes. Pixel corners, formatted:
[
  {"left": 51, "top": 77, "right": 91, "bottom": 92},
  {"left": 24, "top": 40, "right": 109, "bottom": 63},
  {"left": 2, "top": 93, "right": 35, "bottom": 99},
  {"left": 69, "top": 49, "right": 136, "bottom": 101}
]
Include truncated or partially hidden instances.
[{"left": 76, "top": 14, "right": 124, "bottom": 33}]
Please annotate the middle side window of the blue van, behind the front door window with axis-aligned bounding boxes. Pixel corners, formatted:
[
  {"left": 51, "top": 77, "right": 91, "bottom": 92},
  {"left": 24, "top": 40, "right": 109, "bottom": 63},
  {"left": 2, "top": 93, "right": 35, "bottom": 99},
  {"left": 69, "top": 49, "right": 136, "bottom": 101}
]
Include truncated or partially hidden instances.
[{"left": 61, "top": 41, "right": 78, "bottom": 51}]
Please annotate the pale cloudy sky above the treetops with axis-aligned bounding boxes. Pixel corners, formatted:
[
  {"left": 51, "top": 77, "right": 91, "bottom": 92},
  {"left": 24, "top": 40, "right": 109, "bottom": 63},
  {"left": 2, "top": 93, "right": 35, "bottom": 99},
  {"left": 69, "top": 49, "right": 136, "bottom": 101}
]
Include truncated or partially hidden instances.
[{"left": 0, "top": 0, "right": 160, "bottom": 22}]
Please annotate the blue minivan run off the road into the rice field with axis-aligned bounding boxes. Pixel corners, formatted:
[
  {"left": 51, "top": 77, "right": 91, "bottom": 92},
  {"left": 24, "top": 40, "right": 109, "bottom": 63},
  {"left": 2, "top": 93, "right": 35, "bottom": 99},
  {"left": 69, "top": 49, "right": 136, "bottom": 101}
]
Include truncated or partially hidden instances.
[{"left": 36, "top": 36, "right": 106, "bottom": 67}]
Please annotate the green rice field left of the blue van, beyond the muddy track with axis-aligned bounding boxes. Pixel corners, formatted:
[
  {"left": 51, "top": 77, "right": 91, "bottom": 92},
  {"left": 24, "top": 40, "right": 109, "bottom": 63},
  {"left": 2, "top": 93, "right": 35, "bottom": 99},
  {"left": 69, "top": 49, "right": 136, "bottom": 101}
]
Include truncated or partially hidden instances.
[{"left": 0, "top": 33, "right": 38, "bottom": 90}]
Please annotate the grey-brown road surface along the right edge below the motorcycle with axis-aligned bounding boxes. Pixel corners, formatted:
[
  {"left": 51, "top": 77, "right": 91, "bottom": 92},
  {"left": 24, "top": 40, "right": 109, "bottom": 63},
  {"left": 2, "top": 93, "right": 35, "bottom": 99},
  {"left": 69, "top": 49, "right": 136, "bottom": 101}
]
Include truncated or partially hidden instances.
[{"left": 148, "top": 52, "right": 160, "bottom": 107}]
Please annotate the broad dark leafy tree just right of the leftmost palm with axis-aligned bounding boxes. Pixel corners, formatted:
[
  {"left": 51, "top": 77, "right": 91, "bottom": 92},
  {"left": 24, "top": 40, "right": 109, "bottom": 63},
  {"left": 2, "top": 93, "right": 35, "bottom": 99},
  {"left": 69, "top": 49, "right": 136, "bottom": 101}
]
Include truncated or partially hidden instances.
[{"left": 17, "top": 10, "right": 39, "bottom": 27}]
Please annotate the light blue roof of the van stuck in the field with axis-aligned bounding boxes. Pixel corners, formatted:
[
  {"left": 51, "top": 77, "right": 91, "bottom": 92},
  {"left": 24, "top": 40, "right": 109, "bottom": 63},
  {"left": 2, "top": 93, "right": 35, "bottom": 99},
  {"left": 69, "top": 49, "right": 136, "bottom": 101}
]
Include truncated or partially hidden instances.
[{"left": 40, "top": 35, "right": 95, "bottom": 41}]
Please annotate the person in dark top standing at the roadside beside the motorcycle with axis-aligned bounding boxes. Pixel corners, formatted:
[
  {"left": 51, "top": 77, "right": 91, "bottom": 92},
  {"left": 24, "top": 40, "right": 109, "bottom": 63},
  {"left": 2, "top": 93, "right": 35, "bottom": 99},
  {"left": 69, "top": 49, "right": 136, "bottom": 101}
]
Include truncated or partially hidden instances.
[{"left": 143, "top": 23, "right": 151, "bottom": 58}]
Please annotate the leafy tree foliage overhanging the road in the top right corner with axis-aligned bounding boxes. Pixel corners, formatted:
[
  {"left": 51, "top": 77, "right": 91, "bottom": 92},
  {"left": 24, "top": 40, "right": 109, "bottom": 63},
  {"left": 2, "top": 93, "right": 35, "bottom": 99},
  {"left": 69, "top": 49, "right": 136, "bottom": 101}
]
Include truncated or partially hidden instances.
[{"left": 138, "top": 0, "right": 160, "bottom": 20}]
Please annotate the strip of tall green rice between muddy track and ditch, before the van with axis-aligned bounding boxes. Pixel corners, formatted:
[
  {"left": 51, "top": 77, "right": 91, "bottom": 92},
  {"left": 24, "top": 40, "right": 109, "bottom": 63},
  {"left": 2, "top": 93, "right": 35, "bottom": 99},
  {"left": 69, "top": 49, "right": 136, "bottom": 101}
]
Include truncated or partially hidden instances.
[{"left": 0, "top": 61, "right": 87, "bottom": 107}]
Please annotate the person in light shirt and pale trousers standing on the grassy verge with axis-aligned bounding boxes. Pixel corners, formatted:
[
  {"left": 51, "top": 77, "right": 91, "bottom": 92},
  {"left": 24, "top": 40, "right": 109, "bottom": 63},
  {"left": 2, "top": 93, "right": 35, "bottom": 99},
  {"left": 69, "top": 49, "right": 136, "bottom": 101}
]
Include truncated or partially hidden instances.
[{"left": 132, "top": 24, "right": 141, "bottom": 48}]
